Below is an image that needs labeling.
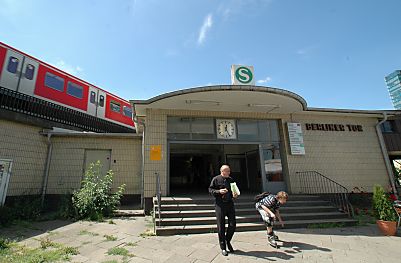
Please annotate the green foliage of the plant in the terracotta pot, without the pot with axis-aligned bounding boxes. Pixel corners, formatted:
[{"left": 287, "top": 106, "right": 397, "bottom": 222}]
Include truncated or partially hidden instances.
[{"left": 372, "top": 185, "right": 397, "bottom": 221}]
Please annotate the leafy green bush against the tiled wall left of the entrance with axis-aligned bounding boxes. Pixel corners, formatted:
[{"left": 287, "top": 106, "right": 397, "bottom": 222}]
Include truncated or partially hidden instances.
[{"left": 72, "top": 161, "right": 125, "bottom": 221}]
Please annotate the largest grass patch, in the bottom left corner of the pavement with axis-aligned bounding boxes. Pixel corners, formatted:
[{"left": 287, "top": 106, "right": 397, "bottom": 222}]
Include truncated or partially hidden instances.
[{"left": 0, "top": 239, "right": 78, "bottom": 263}]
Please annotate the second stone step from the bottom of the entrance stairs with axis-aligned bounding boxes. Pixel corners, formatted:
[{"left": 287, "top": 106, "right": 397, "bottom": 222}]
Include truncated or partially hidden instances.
[{"left": 156, "top": 212, "right": 347, "bottom": 226}]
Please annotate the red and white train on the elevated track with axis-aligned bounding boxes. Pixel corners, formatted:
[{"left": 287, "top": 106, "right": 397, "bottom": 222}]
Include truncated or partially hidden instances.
[{"left": 0, "top": 42, "right": 134, "bottom": 129}]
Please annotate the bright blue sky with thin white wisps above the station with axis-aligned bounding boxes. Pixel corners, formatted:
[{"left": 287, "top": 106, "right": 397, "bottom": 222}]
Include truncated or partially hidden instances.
[{"left": 0, "top": 0, "right": 401, "bottom": 109}]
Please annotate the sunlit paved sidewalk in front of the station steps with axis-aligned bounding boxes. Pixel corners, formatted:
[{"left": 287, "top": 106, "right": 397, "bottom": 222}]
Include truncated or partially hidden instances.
[{"left": 0, "top": 217, "right": 401, "bottom": 263}]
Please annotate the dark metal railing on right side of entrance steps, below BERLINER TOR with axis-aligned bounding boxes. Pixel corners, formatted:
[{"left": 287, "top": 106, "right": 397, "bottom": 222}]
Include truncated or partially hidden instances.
[{"left": 296, "top": 171, "right": 354, "bottom": 217}]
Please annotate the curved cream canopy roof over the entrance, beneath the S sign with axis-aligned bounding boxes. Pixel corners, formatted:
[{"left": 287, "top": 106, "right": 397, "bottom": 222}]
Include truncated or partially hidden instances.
[{"left": 130, "top": 85, "right": 307, "bottom": 116}]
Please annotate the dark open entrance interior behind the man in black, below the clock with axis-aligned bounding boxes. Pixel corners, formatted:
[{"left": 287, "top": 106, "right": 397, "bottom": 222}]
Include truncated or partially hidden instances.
[{"left": 169, "top": 144, "right": 262, "bottom": 195}]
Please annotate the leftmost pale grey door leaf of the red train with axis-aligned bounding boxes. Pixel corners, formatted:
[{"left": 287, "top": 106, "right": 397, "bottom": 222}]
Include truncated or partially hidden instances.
[{"left": 0, "top": 49, "right": 24, "bottom": 90}]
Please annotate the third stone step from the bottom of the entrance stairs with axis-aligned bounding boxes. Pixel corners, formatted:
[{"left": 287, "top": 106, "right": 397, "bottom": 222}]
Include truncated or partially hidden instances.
[{"left": 155, "top": 206, "right": 338, "bottom": 218}]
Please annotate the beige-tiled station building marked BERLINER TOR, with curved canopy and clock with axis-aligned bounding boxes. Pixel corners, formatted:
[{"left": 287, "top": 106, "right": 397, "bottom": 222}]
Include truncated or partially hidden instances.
[{"left": 0, "top": 66, "right": 401, "bottom": 214}]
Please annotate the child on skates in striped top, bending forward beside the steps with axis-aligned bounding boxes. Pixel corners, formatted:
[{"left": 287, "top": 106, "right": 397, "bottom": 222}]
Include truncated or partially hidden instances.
[{"left": 255, "top": 191, "right": 288, "bottom": 248}]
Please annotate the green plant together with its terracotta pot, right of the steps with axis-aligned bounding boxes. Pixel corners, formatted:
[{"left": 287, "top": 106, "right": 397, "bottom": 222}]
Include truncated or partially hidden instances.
[{"left": 372, "top": 185, "right": 397, "bottom": 236}]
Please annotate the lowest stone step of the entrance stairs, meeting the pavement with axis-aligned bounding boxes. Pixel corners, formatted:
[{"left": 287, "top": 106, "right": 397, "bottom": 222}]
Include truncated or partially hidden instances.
[{"left": 156, "top": 218, "right": 357, "bottom": 236}]
